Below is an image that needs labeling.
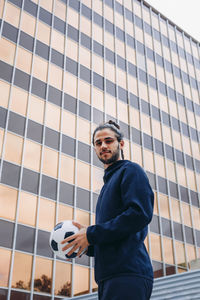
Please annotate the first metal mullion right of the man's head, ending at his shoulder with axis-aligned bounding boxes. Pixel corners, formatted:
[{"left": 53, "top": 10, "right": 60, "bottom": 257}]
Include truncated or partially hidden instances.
[{"left": 122, "top": 0, "right": 133, "bottom": 161}]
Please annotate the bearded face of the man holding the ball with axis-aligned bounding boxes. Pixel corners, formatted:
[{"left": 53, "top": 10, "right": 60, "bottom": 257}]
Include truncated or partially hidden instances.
[{"left": 94, "top": 128, "right": 124, "bottom": 168}]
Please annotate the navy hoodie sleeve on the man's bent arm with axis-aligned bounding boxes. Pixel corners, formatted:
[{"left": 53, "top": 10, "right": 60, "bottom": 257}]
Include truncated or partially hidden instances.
[{"left": 87, "top": 164, "right": 154, "bottom": 245}]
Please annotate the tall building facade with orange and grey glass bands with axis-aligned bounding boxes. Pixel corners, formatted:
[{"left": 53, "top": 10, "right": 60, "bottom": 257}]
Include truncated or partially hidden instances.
[{"left": 0, "top": 0, "right": 200, "bottom": 300}]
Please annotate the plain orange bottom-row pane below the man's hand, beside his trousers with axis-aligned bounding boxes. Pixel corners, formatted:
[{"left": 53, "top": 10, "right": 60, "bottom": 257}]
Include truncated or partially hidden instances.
[{"left": 74, "top": 265, "right": 89, "bottom": 296}]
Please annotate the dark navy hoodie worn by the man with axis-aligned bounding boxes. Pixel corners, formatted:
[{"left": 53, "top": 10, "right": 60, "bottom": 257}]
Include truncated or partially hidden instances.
[{"left": 87, "top": 160, "right": 154, "bottom": 283}]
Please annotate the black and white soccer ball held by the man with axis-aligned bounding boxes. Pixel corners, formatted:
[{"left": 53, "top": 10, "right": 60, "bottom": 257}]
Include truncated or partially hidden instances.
[{"left": 49, "top": 220, "right": 79, "bottom": 259}]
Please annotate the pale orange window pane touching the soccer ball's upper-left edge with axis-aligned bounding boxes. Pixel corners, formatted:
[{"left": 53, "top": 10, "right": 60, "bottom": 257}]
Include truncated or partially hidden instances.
[{"left": 38, "top": 198, "right": 55, "bottom": 231}]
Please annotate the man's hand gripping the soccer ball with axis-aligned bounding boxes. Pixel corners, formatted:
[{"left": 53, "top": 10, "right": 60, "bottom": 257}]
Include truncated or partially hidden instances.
[{"left": 61, "top": 222, "right": 89, "bottom": 257}]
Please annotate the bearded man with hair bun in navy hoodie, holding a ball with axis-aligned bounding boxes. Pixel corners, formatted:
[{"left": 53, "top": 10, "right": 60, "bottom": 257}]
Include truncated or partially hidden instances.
[{"left": 63, "top": 121, "right": 154, "bottom": 300}]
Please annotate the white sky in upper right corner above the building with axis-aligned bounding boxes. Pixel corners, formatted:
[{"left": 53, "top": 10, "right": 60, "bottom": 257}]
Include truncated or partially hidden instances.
[{"left": 146, "top": 0, "right": 200, "bottom": 42}]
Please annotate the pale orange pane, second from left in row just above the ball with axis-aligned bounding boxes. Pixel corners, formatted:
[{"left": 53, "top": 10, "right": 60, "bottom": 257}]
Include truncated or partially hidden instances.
[{"left": 18, "top": 192, "right": 37, "bottom": 226}]
